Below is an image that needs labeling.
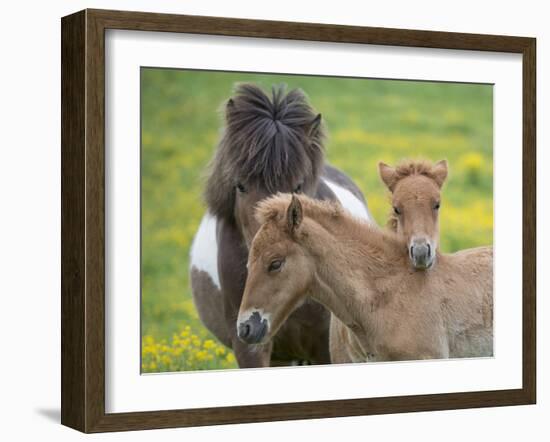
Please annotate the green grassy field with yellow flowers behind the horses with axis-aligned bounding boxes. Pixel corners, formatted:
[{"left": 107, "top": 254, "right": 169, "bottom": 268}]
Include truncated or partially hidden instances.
[{"left": 141, "top": 69, "right": 493, "bottom": 372}]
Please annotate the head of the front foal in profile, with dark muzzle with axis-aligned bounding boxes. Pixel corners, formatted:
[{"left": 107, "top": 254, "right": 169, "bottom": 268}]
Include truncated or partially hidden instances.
[{"left": 237, "top": 198, "right": 314, "bottom": 344}]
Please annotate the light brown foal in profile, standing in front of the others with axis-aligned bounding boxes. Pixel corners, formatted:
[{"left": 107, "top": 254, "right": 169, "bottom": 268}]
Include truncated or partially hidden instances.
[{"left": 237, "top": 195, "right": 493, "bottom": 362}]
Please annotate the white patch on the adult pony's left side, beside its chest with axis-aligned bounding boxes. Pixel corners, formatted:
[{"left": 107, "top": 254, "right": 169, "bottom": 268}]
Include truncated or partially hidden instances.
[{"left": 191, "top": 213, "right": 221, "bottom": 289}]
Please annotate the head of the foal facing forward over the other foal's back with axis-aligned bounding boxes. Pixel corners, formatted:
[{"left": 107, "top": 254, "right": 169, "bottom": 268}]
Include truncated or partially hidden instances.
[{"left": 378, "top": 160, "right": 448, "bottom": 270}]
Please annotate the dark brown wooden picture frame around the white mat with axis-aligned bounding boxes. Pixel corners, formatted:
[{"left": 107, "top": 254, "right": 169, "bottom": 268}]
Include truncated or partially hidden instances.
[{"left": 61, "top": 10, "right": 536, "bottom": 432}]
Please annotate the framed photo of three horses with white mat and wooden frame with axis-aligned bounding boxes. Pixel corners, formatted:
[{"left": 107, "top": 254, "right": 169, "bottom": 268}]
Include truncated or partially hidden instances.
[{"left": 61, "top": 10, "right": 536, "bottom": 432}]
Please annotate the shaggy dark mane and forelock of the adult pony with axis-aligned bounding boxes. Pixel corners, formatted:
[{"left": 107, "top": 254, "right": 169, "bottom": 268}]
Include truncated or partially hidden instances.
[{"left": 205, "top": 84, "right": 324, "bottom": 218}]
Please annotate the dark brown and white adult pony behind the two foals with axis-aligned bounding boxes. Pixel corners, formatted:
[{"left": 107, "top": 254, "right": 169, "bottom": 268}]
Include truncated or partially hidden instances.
[{"left": 190, "top": 84, "right": 370, "bottom": 367}]
